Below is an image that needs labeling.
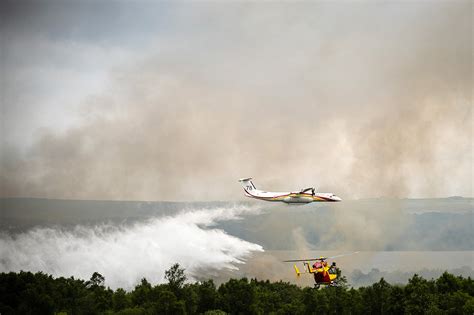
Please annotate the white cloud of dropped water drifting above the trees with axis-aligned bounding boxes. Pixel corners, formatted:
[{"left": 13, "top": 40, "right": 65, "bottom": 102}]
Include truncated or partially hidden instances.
[{"left": 0, "top": 206, "right": 263, "bottom": 288}]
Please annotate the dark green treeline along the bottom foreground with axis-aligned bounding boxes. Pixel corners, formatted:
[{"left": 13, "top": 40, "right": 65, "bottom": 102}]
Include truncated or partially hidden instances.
[{"left": 0, "top": 264, "right": 474, "bottom": 315}]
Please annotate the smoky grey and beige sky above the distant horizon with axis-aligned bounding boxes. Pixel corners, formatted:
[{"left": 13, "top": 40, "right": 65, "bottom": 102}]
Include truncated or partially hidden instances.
[{"left": 0, "top": 1, "right": 473, "bottom": 200}]
